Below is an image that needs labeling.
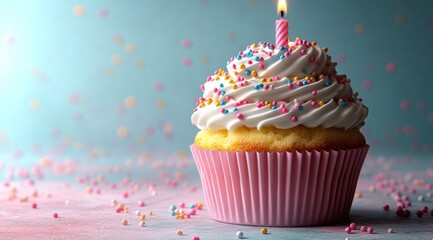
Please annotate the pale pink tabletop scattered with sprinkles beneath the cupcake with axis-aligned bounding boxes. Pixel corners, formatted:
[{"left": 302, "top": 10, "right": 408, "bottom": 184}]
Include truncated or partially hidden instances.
[{"left": 0, "top": 154, "right": 433, "bottom": 239}]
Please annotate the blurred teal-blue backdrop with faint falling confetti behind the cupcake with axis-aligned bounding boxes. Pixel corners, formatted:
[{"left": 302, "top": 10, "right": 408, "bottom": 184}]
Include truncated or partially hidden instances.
[{"left": 0, "top": 0, "right": 433, "bottom": 165}]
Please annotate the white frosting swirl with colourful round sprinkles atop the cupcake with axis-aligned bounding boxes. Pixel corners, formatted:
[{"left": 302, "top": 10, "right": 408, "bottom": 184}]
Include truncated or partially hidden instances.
[{"left": 191, "top": 39, "right": 368, "bottom": 131}]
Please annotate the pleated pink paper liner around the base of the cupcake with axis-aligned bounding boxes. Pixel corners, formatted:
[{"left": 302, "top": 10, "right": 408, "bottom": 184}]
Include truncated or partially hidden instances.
[{"left": 191, "top": 144, "right": 369, "bottom": 227}]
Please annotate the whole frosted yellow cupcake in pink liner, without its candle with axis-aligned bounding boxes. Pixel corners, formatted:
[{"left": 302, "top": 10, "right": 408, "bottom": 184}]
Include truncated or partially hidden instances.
[{"left": 191, "top": 38, "right": 368, "bottom": 226}]
